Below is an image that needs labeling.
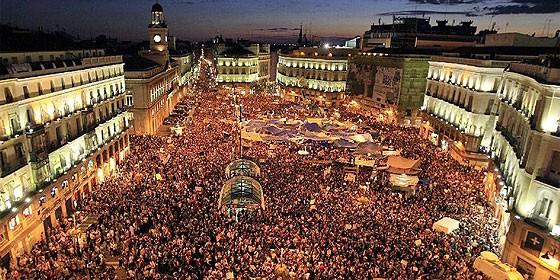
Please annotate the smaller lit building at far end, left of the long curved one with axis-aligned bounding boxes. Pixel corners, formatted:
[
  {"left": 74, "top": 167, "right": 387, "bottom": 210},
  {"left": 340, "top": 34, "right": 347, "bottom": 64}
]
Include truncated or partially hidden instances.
[{"left": 216, "top": 40, "right": 270, "bottom": 87}]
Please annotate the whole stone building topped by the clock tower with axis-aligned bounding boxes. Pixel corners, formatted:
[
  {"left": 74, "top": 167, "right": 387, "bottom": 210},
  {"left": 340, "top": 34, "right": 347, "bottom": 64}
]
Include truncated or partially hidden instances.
[{"left": 125, "top": 3, "right": 186, "bottom": 135}]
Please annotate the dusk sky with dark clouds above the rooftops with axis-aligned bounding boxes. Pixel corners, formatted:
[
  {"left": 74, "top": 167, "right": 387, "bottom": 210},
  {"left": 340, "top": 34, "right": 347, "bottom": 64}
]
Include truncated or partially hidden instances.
[{"left": 0, "top": 0, "right": 560, "bottom": 41}]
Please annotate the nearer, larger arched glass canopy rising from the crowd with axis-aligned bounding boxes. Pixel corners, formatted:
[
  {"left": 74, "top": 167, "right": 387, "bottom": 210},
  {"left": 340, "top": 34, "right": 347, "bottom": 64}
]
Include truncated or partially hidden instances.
[{"left": 218, "top": 176, "right": 264, "bottom": 209}]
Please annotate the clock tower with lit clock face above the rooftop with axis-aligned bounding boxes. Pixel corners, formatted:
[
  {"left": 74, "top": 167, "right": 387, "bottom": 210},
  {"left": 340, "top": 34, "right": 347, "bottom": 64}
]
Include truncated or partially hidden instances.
[{"left": 148, "top": 3, "right": 169, "bottom": 56}]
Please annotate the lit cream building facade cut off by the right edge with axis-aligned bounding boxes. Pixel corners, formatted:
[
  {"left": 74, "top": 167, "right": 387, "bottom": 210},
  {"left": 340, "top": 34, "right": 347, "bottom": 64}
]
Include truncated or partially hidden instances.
[{"left": 490, "top": 61, "right": 560, "bottom": 279}]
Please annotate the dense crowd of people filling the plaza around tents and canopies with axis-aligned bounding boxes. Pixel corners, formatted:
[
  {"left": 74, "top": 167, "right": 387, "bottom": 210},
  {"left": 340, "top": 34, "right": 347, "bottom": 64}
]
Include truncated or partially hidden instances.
[{"left": 6, "top": 55, "right": 497, "bottom": 279}]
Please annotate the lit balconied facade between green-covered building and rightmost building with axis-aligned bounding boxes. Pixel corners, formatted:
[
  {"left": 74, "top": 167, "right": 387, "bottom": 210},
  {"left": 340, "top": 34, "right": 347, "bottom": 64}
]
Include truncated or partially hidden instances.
[{"left": 420, "top": 57, "right": 508, "bottom": 166}]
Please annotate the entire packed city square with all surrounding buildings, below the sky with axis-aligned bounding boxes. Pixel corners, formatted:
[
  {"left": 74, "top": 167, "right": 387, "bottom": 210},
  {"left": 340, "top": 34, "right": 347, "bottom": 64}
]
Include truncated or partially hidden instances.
[{"left": 0, "top": 1, "right": 560, "bottom": 280}]
